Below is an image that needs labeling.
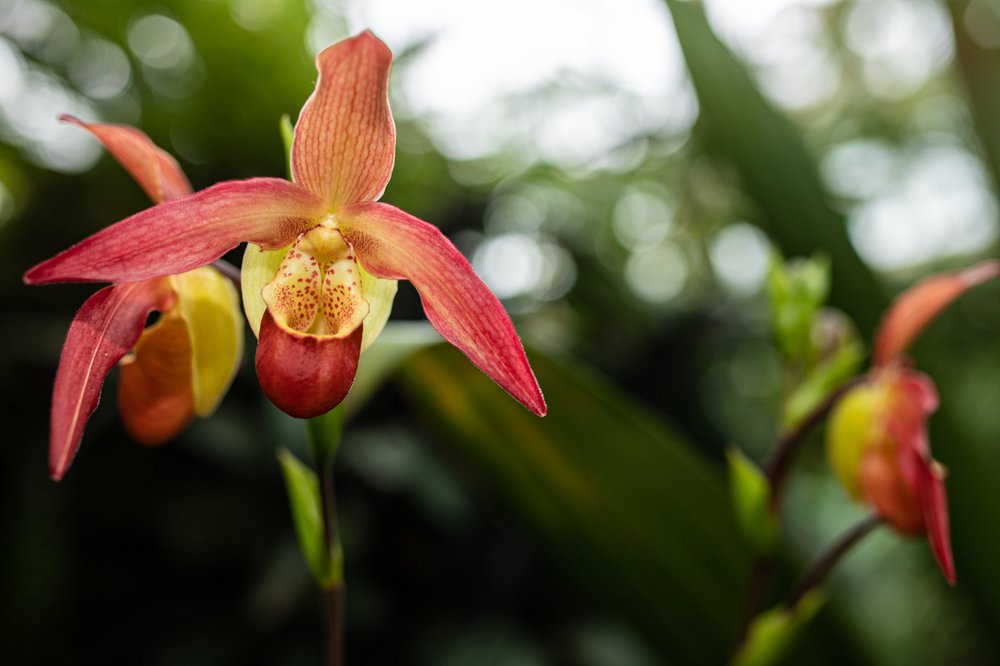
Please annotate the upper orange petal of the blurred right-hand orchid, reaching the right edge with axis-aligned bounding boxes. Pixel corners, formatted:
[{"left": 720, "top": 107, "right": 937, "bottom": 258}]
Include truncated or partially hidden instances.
[{"left": 872, "top": 261, "right": 1000, "bottom": 367}]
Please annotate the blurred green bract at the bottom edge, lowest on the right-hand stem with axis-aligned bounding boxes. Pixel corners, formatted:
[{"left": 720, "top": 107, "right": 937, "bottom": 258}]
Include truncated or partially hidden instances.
[{"left": 733, "top": 590, "right": 826, "bottom": 666}]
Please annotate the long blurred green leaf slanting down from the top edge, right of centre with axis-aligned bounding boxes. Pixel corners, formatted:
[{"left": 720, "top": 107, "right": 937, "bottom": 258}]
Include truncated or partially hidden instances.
[{"left": 666, "top": 0, "right": 886, "bottom": 336}]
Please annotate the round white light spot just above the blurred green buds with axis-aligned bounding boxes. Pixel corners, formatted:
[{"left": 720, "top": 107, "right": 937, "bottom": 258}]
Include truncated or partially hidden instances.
[{"left": 708, "top": 223, "right": 770, "bottom": 294}]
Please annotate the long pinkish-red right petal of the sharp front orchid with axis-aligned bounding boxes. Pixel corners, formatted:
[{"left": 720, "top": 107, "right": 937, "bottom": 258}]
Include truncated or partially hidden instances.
[{"left": 337, "top": 203, "right": 546, "bottom": 416}]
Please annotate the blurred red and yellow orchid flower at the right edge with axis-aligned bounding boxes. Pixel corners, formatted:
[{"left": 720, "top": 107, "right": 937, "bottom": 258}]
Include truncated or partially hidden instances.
[{"left": 827, "top": 262, "right": 1000, "bottom": 584}]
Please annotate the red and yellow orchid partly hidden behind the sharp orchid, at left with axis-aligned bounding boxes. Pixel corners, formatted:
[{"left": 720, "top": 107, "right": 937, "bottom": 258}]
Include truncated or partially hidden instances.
[{"left": 40, "top": 116, "right": 243, "bottom": 481}]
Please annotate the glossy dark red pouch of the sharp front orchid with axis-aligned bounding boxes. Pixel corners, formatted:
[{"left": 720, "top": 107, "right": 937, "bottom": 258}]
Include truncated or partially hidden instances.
[{"left": 257, "top": 311, "right": 363, "bottom": 419}]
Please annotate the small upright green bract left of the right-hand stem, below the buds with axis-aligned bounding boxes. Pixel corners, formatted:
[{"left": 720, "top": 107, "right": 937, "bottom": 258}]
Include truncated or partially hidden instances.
[{"left": 726, "top": 448, "right": 780, "bottom": 555}]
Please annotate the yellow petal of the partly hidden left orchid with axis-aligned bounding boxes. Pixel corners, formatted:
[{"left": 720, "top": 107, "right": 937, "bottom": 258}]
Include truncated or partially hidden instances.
[{"left": 169, "top": 266, "right": 243, "bottom": 416}]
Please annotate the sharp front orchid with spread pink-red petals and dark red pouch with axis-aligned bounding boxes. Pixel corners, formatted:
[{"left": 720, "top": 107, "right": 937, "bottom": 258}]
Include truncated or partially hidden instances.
[{"left": 25, "top": 32, "right": 546, "bottom": 418}]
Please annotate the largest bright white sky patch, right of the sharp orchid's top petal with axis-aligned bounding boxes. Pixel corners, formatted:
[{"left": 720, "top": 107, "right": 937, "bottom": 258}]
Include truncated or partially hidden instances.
[{"left": 346, "top": 0, "right": 697, "bottom": 170}]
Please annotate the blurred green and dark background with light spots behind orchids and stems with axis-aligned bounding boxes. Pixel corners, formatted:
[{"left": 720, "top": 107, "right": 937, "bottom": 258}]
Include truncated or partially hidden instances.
[{"left": 0, "top": 0, "right": 1000, "bottom": 666}]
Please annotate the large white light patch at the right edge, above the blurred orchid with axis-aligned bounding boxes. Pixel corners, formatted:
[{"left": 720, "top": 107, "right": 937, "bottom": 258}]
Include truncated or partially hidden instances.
[{"left": 850, "top": 146, "right": 997, "bottom": 270}]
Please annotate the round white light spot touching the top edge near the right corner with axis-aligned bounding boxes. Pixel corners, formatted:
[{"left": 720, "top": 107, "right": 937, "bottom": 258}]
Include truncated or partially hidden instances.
[{"left": 845, "top": 0, "right": 954, "bottom": 98}]
